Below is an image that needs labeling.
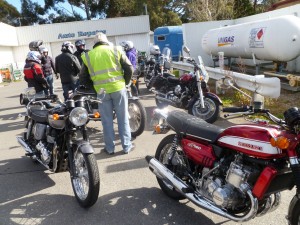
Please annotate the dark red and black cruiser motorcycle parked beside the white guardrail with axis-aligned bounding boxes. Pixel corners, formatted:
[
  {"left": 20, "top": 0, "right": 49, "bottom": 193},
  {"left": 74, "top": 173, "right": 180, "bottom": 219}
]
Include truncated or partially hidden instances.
[{"left": 149, "top": 48, "right": 222, "bottom": 123}]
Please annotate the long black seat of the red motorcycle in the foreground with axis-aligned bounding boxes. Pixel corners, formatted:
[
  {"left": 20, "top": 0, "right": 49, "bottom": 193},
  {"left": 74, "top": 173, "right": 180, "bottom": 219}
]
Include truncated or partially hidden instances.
[{"left": 167, "top": 110, "right": 224, "bottom": 143}]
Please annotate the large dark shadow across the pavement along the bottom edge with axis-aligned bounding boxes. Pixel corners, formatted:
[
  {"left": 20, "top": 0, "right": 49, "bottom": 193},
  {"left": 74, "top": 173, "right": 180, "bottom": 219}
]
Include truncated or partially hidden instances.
[{"left": 0, "top": 188, "right": 214, "bottom": 225}]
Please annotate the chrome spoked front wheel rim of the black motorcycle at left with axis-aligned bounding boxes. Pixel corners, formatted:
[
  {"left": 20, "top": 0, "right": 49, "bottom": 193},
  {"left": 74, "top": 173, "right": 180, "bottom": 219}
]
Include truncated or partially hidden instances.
[{"left": 72, "top": 152, "right": 89, "bottom": 200}]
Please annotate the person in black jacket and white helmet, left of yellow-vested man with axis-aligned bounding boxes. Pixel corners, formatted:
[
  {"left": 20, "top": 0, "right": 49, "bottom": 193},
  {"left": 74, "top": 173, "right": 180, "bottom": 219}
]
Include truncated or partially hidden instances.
[{"left": 55, "top": 41, "right": 81, "bottom": 101}]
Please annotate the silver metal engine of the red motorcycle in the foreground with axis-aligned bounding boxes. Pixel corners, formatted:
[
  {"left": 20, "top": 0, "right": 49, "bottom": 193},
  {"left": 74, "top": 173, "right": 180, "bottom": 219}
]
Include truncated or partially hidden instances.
[{"left": 201, "top": 162, "right": 250, "bottom": 208}]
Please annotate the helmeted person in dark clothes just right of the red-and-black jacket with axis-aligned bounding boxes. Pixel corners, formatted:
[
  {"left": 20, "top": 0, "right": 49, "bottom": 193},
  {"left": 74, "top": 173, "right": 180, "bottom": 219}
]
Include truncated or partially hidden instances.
[{"left": 42, "top": 48, "right": 58, "bottom": 95}]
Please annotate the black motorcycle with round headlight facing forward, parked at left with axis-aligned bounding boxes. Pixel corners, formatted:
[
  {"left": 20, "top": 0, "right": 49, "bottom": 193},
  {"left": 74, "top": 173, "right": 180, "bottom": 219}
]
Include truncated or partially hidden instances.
[{"left": 17, "top": 88, "right": 100, "bottom": 208}]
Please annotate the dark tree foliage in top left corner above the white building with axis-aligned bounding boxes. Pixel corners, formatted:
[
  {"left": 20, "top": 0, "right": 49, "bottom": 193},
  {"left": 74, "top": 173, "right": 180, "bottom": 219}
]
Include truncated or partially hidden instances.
[{"left": 0, "top": 0, "right": 20, "bottom": 26}]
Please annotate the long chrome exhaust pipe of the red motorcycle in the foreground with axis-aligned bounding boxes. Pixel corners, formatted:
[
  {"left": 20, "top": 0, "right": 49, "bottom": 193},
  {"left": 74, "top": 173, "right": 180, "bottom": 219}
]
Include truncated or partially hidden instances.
[{"left": 146, "top": 156, "right": 258, "bottom": 222}]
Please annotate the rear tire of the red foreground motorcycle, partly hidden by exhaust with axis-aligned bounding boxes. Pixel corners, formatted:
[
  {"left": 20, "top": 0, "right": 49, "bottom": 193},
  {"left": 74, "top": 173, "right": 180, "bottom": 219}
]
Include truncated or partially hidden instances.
[{"left": 155, "top": 134, "right": 185, "bottom": 200}]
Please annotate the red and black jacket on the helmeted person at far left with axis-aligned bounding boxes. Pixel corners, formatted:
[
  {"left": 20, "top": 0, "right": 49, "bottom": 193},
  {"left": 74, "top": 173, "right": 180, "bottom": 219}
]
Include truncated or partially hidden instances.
[{"left": 23, "top": 61, "right": 49, "bottom": 92}]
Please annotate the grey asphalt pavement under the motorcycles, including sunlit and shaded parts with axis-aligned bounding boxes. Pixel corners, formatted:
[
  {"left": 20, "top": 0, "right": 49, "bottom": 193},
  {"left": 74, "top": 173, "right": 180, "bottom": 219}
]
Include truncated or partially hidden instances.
[{"left": 0, "top": 80, "right": 295, "bottom": 225}]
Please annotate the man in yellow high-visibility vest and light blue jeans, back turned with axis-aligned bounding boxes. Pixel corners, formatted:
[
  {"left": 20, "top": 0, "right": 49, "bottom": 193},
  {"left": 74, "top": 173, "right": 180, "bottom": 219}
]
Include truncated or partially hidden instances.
[{"left": 79, "top": 33, "right": 134, "bottom": 155}]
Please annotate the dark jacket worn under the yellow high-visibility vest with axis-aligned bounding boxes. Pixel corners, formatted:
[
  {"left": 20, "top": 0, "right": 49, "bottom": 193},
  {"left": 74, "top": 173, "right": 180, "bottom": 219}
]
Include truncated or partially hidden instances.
[{"left": 79, "top": 42, "right": 133, "bottom": 90}]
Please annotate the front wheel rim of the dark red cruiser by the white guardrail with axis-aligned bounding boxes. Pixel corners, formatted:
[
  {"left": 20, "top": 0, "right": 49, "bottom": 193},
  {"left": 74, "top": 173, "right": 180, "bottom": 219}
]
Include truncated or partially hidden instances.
[{"left": 192, "top": 98, "right": 217, "bottom": 120}]
